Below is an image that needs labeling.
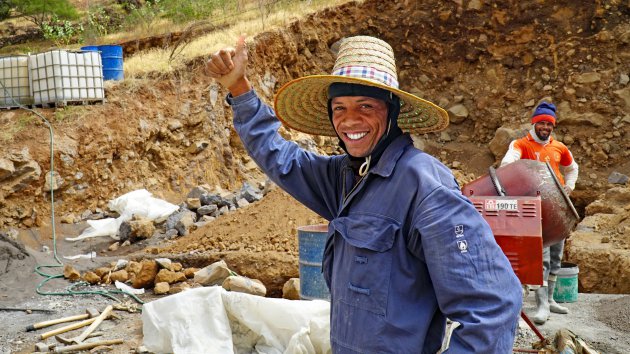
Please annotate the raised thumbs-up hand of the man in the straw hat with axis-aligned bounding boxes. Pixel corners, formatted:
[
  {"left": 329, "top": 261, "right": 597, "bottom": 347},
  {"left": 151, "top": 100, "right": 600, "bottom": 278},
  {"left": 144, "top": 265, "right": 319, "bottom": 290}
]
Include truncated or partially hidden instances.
[{"left": 206, "top": 36, "right": 251, "bottom": 96}]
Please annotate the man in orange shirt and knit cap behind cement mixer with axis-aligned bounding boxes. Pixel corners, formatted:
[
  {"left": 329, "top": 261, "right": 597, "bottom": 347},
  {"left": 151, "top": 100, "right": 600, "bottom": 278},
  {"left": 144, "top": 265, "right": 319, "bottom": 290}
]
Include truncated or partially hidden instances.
[{"left": 501, "top": 101, "right": 578, "bottom": 324}]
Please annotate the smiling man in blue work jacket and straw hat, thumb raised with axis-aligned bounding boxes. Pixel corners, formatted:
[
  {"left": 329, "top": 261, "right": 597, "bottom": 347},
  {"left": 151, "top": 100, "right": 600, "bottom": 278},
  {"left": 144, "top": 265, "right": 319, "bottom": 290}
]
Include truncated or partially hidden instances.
[{"left": 207, "top": 36, "right": 522, "bottom": 354}]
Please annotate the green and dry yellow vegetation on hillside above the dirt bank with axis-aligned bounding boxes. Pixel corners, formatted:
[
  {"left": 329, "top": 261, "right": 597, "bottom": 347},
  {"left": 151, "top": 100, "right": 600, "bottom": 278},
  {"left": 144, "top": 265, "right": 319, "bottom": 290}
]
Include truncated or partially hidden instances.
[{"left": 0, "top": 0, "right": 356, "bottom": 74}]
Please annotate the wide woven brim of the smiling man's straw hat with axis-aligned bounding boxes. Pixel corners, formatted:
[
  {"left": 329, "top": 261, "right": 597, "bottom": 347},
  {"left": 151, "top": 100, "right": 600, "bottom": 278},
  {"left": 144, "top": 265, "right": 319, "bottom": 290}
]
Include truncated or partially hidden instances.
[{"left": 274, "top": 75, "right": 448, "bottom": 137}]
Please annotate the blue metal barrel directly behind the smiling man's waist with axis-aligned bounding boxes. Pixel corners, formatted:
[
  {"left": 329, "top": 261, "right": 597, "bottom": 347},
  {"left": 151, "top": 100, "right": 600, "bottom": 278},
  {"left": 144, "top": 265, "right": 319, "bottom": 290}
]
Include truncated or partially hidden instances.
[{"left": 298, "top": 224, "right": 330, "bottom": 300}]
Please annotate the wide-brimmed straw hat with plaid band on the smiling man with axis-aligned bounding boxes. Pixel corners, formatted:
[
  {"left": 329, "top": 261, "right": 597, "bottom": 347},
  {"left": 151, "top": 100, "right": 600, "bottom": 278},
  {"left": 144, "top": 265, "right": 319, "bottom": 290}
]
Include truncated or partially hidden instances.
[{"left": 274, "top": 36, "right": 448, "bottom": 136}]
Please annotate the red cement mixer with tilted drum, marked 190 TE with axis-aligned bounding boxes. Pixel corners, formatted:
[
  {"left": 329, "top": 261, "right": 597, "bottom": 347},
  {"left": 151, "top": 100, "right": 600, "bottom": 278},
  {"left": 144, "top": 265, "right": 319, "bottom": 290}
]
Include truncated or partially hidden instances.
[{"left": 462, "top": 159, "right": 579, "bottom": 343}]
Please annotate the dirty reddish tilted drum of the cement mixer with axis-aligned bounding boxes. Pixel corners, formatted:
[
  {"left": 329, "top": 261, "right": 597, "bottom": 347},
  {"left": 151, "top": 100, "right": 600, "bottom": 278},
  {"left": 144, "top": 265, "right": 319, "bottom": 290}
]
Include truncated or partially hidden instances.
[{"left": 462, "top": 159, "right": 579, "bottom": 247}]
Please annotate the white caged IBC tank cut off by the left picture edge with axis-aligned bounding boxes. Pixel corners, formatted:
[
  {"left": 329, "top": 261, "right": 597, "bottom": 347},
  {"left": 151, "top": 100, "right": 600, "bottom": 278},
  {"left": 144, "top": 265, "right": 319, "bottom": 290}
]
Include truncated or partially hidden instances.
[{"left": 0, "top": 55, "right": 33, "bottom": 107}]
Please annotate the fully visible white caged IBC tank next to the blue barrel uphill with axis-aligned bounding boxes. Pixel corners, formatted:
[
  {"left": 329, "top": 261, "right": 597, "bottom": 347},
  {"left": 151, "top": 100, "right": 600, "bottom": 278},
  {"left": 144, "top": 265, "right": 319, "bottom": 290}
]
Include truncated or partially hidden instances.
[{"left": 29, "top": 50, "right": 105, "bottom": 104}]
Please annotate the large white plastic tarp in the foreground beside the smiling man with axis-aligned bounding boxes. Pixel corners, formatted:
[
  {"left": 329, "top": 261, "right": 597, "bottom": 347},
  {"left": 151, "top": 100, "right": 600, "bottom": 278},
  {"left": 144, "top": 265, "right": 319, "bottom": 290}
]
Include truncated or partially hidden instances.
[{"left": 142, "top": 286, "right": 331, "bottom": 354}]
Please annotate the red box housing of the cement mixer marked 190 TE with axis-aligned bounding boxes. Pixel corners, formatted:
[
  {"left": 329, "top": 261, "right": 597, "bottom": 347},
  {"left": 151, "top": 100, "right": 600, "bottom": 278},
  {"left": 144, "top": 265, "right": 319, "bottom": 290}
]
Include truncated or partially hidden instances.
[{"left": 470, "top": 196, "right": 543, "bottom": 285}]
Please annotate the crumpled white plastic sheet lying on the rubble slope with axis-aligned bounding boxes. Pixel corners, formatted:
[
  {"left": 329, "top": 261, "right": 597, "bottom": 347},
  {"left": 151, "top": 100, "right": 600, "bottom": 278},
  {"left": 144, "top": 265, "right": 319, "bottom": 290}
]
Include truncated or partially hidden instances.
[{"left": 66, "top": 189, "right": 179, "bottom": 241}]
